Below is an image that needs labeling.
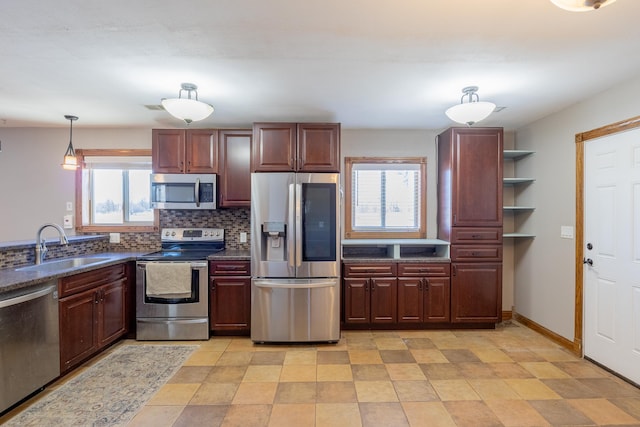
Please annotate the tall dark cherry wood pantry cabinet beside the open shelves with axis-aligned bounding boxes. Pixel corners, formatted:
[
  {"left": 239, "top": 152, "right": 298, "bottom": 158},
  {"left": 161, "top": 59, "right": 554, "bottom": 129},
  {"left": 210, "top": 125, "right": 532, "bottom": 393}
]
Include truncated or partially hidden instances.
[{"left": 438, "top": 128, "right": 503, "bottom": 324}]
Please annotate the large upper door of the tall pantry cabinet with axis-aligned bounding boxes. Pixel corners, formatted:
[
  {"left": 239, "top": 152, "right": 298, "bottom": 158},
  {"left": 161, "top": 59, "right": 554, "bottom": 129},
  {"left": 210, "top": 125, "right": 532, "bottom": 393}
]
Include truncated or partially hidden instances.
[{"left": 451, "top": 128, "right": 503, "bottom": 227}]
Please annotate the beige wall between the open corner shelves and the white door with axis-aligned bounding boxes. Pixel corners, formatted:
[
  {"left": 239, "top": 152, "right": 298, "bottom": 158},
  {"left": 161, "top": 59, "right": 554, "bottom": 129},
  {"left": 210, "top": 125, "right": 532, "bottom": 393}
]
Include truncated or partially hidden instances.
[{"left": 514, "top": 72, "right": 640, "bottom": 340}]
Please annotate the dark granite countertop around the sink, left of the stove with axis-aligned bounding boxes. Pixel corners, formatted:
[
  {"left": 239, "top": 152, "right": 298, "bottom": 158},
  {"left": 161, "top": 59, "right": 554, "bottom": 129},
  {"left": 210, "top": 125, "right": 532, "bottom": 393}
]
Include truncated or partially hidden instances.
[{"left": 0, "top": 252, "right": 143, "bottom": 295}]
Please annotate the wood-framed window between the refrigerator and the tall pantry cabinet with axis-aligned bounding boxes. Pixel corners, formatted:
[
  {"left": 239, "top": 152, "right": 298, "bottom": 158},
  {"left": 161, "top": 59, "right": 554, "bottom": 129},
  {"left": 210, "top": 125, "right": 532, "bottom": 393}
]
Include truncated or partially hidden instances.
[{"left": 345, "top": 157, "right": 427, "bottom": 239}]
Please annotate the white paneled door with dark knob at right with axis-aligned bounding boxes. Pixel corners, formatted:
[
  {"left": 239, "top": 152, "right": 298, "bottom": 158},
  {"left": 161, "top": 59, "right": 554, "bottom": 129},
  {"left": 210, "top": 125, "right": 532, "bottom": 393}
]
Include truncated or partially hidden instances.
[{"left": 583, "top": 130, "right": 640, "bottom": 384}]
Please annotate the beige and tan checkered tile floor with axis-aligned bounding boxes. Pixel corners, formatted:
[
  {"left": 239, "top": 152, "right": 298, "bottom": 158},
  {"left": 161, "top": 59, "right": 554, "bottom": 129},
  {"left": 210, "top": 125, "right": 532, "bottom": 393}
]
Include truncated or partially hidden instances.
[{"left": 1, "top": 322, "right": 640, "bottom": 427}]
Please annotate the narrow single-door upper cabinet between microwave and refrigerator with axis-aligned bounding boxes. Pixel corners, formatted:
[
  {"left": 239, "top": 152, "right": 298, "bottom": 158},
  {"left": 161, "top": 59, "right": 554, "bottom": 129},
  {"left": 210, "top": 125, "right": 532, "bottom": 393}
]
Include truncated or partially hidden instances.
[{"left": 218, "top": 129, "right": 252, "bottom": 207}]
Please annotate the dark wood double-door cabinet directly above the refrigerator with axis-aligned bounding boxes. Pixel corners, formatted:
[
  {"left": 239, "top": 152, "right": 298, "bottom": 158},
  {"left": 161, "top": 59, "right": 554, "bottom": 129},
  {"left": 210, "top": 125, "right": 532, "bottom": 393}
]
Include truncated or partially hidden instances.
[{"left": 252, "top": 123, "right": 340, "bottom": 172}]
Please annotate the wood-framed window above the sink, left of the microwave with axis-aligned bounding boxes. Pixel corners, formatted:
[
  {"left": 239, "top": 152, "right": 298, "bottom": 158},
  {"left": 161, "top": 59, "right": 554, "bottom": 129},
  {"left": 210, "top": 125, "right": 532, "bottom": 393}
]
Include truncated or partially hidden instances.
[{"left": 76, "top": 149, "right": 158, "bottom": 232}]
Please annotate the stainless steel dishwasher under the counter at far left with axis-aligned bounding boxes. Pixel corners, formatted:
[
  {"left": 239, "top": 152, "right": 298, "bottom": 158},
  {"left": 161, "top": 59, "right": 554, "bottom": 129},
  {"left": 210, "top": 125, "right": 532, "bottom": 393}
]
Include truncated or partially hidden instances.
[{"left": 0, "top": 281, "right": 60, "bottom": 412}]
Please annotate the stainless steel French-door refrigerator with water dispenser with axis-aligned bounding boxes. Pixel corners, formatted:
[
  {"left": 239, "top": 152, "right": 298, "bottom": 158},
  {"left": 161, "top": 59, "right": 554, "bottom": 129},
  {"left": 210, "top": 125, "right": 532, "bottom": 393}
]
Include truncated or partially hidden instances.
[{"left": 251, "top": 173, "right": 340, "bottom": 342}]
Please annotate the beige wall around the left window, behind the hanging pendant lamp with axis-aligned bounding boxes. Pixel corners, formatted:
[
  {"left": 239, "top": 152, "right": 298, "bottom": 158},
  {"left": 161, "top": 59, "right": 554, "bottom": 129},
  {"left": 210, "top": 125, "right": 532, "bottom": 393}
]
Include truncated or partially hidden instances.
[{"left": 0, "top": 126, "right": 151, "bottom": 242}]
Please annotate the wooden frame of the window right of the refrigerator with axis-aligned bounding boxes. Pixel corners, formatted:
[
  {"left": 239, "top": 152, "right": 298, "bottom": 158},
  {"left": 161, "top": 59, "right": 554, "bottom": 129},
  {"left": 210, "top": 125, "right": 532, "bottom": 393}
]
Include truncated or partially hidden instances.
[{"left": 344, "top": 157, "right": 427, "bottom": 239}]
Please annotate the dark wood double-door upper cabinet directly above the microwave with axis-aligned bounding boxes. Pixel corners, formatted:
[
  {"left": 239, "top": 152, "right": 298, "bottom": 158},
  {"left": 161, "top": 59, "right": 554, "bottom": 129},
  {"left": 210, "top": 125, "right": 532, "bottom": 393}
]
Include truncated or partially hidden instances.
[{"left": 151, "top": 129, "right": 218, "bottom": 173}]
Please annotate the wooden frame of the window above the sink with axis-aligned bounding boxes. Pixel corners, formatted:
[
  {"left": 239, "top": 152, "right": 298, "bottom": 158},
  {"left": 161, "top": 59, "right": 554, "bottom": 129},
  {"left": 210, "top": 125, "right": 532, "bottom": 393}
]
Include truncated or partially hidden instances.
[{"left": 75, "top": 149, "right": 160, "bottom": 233}]
